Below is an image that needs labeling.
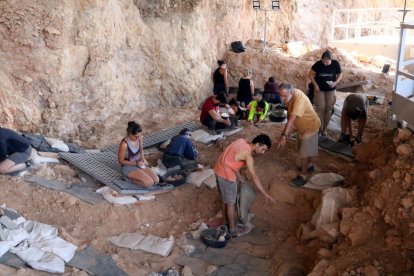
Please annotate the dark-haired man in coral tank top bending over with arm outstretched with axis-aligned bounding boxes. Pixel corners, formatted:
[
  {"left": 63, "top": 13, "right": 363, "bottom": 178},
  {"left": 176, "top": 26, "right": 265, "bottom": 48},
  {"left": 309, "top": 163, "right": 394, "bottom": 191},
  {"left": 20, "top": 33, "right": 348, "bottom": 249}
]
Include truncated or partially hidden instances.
[{"left": 214, "top": 134, "right": 275, "bottom": 237}]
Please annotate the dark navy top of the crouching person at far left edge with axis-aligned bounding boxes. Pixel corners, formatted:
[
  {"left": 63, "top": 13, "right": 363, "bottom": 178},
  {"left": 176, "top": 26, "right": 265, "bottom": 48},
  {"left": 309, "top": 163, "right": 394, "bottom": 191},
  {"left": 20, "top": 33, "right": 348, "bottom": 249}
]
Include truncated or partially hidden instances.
[{"left": 0, "top": 128, "right": 30, "bottom": 161}]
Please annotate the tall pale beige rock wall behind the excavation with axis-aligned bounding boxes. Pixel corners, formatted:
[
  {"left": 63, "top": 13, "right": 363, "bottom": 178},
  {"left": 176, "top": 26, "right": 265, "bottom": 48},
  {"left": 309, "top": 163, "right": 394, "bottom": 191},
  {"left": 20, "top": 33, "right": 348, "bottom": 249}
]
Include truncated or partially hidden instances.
[{"left": 0, "top": 0, "right": 408, "bottom": 144}]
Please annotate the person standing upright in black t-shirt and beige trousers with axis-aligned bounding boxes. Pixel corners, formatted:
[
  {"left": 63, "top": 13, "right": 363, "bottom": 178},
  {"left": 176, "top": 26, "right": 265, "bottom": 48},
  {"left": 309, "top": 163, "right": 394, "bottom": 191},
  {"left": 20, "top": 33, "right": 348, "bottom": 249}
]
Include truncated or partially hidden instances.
[{"left": 308, "top": 51, "right": 342, "bottom": 136}]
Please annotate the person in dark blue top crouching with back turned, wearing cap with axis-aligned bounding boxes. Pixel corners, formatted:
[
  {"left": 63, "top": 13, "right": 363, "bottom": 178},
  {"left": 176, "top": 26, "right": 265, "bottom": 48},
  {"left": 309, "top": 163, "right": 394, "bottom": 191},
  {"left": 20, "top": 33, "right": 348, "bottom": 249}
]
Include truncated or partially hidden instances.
[{"left": 162, "top": 128, "right": 197, "bottom": 170}]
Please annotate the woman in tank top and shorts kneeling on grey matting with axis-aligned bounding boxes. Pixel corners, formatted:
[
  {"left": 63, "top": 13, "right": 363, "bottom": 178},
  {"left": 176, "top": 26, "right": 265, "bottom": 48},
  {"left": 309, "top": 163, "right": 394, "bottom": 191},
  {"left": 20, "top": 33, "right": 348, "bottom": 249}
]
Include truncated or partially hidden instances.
[{"left": 118, "top": 121, "right": 159, "bottom": 188}]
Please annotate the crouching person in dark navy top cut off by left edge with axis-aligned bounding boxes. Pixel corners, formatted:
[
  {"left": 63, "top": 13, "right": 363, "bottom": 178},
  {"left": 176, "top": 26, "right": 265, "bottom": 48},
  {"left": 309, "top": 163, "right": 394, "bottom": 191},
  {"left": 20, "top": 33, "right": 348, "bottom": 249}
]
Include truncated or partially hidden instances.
[{"left": 0, "top": 127, "right": 32, "bottom": 173}]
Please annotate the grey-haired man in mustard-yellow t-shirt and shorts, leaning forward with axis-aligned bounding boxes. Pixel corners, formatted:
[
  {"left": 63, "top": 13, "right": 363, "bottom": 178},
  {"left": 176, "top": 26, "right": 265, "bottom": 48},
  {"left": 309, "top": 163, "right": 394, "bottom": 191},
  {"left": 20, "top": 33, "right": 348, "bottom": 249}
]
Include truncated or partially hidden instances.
[{"left": 278, "top": 83, "right": 321, "bottom": 187}]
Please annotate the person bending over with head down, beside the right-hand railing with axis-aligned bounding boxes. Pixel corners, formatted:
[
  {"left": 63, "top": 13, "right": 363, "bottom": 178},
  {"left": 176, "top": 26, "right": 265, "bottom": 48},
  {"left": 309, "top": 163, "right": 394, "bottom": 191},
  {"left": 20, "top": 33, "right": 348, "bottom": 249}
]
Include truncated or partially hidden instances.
[{"left": 338, "top": 94, "right": 368, "bottom": 145}]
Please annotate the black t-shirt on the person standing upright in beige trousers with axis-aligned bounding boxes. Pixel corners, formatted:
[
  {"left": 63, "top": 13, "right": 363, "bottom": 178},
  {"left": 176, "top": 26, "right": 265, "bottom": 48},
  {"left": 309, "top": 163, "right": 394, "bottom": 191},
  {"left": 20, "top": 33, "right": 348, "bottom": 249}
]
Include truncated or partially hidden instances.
[{"left": 312, "top": 59, "right": 342, "bottom": 91}]
